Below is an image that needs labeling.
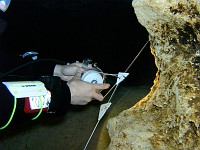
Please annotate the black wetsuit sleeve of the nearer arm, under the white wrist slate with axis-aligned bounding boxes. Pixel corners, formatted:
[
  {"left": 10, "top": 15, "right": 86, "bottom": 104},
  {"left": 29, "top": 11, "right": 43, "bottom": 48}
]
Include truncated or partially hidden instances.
[{"left": 0, "top": 68, "right": 71, "bottom": 129}]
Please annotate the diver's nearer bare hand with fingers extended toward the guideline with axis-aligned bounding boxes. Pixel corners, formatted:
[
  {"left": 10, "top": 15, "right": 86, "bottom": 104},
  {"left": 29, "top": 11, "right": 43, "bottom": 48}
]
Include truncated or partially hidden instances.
[{"left": 67, "top": 72, "right": 110, "bottom": 105}]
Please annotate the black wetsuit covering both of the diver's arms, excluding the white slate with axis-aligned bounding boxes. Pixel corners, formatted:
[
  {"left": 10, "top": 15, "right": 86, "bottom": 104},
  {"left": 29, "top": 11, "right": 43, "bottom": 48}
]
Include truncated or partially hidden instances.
[{"left": 0, "top": 58, "right": 71, "bottom": 128}]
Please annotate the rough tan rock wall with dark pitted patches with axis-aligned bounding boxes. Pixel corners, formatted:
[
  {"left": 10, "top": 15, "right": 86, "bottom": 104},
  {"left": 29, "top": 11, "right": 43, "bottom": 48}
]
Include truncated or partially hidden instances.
[{"left": 107, "top": 0, "right": 200, "bottom": 150}]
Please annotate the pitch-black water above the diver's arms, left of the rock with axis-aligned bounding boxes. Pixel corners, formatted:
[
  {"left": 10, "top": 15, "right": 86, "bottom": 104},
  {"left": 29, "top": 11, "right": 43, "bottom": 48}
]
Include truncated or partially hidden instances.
[{"left": 0, "top": 0, "right": 156, "bottom": 85}]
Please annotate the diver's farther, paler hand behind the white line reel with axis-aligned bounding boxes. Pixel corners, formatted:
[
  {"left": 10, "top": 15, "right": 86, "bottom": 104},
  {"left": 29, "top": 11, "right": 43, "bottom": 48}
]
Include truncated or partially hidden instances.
[{"left": 53, "top": 63, "right": 92, "bottom": 81}]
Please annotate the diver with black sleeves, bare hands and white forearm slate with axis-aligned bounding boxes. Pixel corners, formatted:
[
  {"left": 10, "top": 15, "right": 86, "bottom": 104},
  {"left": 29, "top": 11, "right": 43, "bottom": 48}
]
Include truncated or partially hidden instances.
[{"left": 0, "top": 0, "right": 110, "bottom": 129}]
